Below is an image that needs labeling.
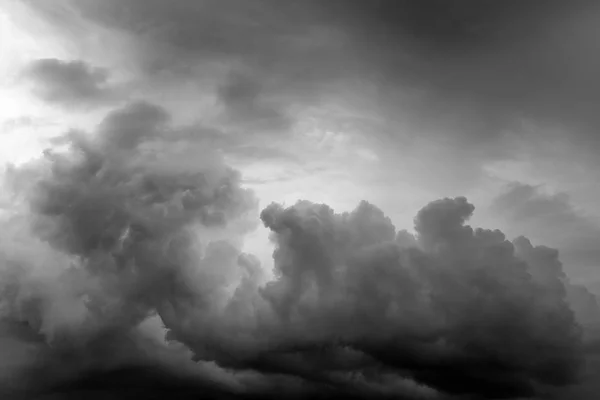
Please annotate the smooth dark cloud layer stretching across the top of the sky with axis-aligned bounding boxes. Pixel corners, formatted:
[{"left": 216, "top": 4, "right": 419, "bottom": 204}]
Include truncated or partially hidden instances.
[{"left": 23, "top": 0, "right": 600, "bottom": 193}]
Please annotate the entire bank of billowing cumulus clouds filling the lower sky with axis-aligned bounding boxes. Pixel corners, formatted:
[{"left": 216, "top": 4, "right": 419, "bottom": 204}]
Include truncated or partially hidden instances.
[{"left": 0, "top": 102, "right": 596, "bottom": 399}]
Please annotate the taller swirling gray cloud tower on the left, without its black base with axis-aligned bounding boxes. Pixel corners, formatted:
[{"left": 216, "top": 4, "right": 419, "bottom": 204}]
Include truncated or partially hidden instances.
[{"left": 1, "top": 98, "right": 256, "bottom": 390}]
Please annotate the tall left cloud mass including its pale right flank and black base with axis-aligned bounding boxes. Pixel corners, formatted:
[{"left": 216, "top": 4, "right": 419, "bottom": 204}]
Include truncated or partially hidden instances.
[{"left": 0, "top": 102, "right": 426, "bottom": 399}]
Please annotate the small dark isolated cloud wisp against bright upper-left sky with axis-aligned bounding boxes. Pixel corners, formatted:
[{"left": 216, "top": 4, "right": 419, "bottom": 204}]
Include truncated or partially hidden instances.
[{"left": 25, "top": 58, "right": 118, "bottom": 107}]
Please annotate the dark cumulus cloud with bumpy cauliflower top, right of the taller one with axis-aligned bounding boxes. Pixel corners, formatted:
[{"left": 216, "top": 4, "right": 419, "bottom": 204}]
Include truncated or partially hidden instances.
[{"left": 262, "top": 198, "right": 578, "bottom": 397}]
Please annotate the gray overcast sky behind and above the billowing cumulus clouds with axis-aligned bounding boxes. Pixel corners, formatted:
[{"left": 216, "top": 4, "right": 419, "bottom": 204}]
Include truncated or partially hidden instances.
[{"left": 0, "top": 0, "right": 600, "bottom": 398}]
